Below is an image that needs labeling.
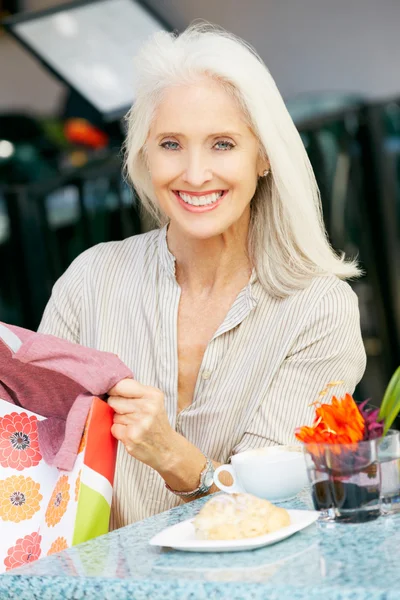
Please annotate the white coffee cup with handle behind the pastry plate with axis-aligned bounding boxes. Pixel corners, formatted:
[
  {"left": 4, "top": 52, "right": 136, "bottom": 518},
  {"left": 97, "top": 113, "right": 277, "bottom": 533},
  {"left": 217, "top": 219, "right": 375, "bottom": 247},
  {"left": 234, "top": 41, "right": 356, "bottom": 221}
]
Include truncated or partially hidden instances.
[{"left": 214, "top": 446, "right": 308, "bottom": 502}]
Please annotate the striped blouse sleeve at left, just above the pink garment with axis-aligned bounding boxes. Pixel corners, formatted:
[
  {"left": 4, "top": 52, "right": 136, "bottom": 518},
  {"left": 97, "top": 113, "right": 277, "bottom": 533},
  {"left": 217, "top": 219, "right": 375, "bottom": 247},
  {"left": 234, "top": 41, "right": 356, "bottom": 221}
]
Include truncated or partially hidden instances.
[{"left": 38, "top": 248, "right": 93, "bottom": 343}]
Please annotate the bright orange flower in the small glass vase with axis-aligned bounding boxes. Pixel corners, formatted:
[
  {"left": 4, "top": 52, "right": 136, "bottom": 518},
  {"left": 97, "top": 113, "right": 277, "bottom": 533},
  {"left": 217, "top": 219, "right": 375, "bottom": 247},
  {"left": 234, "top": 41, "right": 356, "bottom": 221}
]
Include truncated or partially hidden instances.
[{"left": 295, "top": 394, "right": 365, "bottom": 444}]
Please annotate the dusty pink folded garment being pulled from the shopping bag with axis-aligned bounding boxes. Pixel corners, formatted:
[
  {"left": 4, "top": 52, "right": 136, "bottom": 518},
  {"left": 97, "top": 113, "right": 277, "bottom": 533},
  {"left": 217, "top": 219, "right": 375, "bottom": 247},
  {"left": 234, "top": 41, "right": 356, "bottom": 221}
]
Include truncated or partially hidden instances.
[{"left": 0, "top": 322, "right": 133, "bottom": 471}]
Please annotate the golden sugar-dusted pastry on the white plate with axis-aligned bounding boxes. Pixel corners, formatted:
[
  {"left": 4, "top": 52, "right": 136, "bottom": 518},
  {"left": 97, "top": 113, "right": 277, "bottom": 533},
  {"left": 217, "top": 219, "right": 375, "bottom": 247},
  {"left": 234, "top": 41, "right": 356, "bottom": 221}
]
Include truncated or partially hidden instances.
[{"left": 193, "top": 494, "right": 290, "bottom": 540}]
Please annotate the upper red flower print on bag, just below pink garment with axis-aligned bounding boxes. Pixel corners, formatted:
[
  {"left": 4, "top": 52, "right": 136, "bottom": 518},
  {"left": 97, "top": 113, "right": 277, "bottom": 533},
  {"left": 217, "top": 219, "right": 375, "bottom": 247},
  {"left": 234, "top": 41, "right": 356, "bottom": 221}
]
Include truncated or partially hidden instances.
[{"left": 0, "top": 412, "right": 42, "bottom": 471}]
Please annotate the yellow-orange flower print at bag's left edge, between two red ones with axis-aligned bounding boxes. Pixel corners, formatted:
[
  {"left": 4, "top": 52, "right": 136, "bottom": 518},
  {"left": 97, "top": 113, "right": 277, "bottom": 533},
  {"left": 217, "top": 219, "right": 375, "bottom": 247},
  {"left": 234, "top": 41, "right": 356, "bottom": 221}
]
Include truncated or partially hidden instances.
[{"left": 0, "top": 475, "right": 43, "bottom": 523}]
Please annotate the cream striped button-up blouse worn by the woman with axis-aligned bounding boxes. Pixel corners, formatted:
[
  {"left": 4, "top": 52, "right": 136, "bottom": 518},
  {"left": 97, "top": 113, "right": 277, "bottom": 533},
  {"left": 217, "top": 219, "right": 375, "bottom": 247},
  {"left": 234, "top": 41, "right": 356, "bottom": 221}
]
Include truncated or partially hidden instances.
[{"left": 39, "top": 227, "right": 365, "bottom": 529}]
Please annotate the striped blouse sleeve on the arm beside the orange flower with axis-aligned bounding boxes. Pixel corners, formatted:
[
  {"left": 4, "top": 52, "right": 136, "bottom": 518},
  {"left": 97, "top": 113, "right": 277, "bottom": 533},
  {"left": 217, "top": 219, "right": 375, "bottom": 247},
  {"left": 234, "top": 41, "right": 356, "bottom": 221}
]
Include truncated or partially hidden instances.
[{"left": 232, "top": 281, "right": 366, "bottom": 454}]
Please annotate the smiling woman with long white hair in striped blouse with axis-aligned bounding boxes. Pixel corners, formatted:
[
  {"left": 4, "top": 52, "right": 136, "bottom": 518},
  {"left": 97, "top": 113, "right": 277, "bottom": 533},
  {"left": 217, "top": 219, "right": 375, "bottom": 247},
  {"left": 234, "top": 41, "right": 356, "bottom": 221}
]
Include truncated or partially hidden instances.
[{"left": 40, "top": 24, "right": 365, "bottom": 528}]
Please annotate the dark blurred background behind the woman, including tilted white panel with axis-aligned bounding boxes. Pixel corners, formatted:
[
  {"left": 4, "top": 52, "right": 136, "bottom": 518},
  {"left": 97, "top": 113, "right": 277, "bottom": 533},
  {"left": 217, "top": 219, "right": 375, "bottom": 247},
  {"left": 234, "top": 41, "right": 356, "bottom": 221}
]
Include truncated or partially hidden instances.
[{"left": 0, "top": 0, "right": 400, "bottom": 405}]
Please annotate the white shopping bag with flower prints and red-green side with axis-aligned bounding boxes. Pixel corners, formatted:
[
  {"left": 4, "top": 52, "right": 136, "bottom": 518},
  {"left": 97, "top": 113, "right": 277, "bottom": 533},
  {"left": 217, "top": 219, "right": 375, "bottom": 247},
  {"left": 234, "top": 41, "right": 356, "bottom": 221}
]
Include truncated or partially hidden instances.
[{"left": 0, "top": 397, "right": 117, "bottom": 572}]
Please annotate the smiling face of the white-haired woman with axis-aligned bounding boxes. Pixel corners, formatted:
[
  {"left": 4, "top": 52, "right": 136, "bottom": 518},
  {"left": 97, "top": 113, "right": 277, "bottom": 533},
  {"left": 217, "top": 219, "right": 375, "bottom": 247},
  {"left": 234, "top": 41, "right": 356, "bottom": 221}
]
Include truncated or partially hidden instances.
[{"left": 146, "top": 79, "right": 268, "bottom": 239}]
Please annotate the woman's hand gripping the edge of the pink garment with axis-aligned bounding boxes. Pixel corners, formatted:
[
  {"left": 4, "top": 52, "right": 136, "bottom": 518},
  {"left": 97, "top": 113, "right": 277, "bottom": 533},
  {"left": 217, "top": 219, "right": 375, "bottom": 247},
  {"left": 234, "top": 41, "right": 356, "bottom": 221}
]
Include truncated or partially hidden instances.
[{"left": 108, "top": 379, "right": 180, "bottom": 472}]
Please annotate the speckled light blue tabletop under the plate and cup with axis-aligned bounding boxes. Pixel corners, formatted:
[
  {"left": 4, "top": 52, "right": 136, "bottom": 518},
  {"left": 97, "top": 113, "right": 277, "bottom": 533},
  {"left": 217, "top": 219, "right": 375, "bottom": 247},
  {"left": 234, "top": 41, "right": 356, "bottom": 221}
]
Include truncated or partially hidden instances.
[{"left": 0, "top": 494, "right": 400, "bottom": 600}]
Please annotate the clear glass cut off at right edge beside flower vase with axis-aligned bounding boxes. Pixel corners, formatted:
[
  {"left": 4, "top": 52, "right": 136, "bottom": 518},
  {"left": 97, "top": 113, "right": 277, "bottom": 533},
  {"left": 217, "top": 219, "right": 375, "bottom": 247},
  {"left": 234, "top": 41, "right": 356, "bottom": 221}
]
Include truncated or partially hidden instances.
[{"left": 378, "top": 429, "right": 400, "bottom": 515}]
